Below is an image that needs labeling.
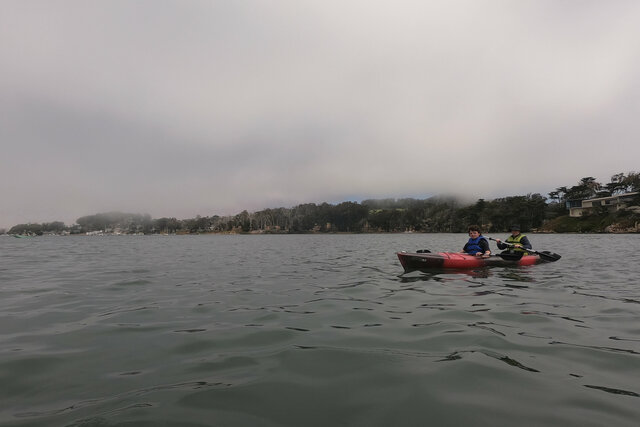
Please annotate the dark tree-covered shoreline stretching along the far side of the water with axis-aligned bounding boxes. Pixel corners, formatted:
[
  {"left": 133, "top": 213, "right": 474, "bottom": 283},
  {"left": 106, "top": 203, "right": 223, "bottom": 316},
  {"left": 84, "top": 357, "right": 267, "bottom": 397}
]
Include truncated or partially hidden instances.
[{"left": 0, "top": 172, "right": 640, "bottom": 237}]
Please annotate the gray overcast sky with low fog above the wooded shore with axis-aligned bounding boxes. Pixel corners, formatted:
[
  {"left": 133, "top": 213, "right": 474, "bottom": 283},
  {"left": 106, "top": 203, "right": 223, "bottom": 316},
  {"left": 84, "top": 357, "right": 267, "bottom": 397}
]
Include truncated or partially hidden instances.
[{"left": 0, "top": 0, "right": 640, "bottom": 231}]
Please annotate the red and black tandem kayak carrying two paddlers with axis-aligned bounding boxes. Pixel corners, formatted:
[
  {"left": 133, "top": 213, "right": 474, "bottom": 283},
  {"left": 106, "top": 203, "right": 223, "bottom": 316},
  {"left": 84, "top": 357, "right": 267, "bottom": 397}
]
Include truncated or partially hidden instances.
[{"left": 397, "top": 252, "right": 548, "bottom": 273}]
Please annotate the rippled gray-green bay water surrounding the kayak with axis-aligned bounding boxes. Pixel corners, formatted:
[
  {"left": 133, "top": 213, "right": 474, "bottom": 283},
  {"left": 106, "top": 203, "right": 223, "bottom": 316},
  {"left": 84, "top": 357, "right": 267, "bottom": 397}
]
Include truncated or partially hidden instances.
[{"left": 0, "top": 234, "right": 640, "bottom": 426}]
